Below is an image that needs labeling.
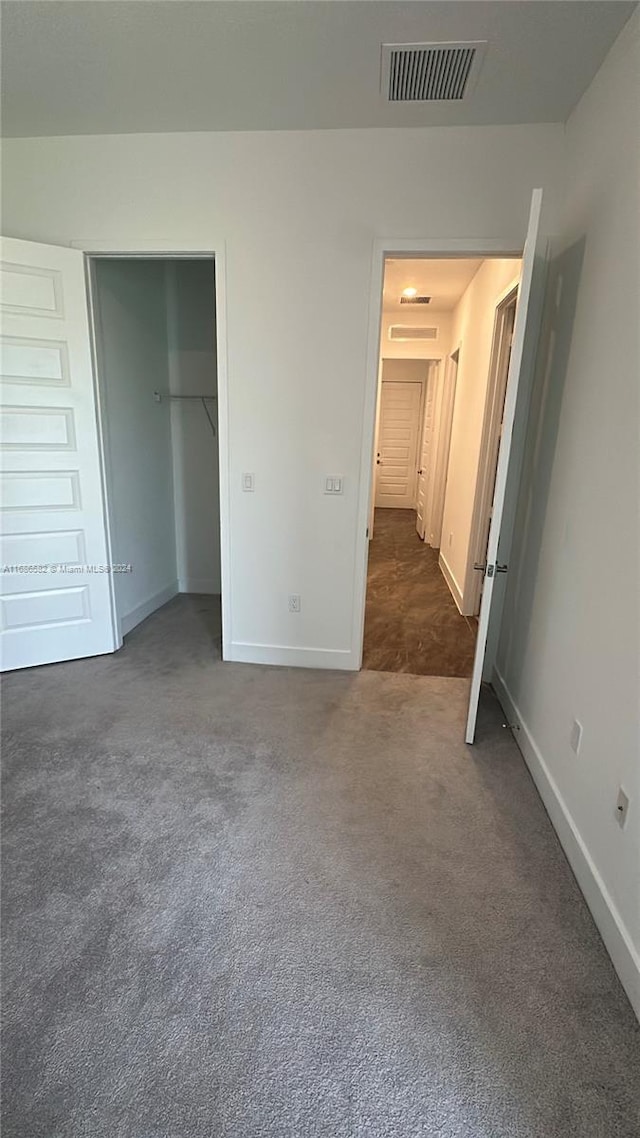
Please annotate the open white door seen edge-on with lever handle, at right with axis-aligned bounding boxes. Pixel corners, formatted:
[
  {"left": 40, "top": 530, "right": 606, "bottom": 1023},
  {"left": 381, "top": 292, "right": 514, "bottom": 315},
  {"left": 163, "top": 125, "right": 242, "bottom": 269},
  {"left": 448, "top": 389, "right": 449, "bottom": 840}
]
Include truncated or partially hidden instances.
[{"left": 465, "top": 190, "right": 542, "bottom": 743}]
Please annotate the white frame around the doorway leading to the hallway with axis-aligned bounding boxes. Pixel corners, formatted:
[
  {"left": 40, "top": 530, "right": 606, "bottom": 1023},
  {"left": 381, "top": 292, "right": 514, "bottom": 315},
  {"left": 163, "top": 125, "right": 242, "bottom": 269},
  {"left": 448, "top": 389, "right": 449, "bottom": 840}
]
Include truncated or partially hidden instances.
[{"left": 352, "top": 237, "right": 523, "bottom": 668}]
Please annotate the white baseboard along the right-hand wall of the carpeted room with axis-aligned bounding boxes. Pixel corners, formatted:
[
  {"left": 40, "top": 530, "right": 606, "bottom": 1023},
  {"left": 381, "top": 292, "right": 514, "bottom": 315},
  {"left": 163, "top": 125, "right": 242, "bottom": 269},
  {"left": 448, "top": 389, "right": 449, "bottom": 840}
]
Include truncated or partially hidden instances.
[{"left": 492, "top": 668, "right": 640, "bottom": 1020}]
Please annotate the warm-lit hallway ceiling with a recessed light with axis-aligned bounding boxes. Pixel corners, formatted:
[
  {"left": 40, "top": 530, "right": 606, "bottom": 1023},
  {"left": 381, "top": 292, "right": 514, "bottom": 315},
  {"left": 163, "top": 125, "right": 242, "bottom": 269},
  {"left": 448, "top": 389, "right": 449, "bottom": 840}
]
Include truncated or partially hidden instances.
[{"left": 383, "top": 257, "right": 482, "bottom": 319}]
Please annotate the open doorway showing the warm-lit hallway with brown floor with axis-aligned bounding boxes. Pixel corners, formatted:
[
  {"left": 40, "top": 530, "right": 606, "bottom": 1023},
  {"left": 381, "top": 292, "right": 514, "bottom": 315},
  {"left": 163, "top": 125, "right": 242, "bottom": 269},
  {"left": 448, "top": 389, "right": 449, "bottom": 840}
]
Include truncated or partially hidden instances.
[{"left": 362, "top": 257, "right": 520, "bottom": 678}]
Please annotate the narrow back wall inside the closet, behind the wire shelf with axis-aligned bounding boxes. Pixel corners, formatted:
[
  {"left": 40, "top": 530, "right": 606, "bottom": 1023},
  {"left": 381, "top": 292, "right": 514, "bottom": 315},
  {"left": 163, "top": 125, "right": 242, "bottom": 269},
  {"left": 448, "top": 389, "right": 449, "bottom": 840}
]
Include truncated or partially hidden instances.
[{"left": 166, "top": 261, "right": 220, "bottom": 593}]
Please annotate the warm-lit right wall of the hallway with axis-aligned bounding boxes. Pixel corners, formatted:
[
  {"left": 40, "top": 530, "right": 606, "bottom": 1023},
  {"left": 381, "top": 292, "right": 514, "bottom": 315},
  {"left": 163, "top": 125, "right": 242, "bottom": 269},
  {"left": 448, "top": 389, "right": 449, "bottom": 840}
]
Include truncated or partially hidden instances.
[{"left": 440, "top": 258, "right": 520, "bottom": 616}]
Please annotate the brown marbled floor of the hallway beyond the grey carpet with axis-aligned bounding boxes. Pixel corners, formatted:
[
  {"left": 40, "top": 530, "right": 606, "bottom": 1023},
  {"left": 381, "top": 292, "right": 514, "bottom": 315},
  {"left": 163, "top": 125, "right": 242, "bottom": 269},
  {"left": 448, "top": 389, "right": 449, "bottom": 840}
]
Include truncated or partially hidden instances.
[{"left": 362, "top": 509, "right": 476, "bottom": 677}]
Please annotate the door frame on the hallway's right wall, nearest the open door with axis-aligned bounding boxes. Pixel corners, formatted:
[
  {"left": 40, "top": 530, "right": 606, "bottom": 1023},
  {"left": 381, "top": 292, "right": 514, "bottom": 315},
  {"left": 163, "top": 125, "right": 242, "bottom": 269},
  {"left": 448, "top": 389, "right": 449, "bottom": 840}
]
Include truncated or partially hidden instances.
[{"left": 462, "top": 284, "right": 519, "bottom": 616}]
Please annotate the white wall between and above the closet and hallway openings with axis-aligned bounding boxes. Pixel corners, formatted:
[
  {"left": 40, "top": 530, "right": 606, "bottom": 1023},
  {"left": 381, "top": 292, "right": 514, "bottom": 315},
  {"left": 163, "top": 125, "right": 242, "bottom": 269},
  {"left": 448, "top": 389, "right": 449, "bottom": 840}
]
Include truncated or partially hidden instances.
[{"left": 3, "top": 125, "right": 563, "bottom": 667}]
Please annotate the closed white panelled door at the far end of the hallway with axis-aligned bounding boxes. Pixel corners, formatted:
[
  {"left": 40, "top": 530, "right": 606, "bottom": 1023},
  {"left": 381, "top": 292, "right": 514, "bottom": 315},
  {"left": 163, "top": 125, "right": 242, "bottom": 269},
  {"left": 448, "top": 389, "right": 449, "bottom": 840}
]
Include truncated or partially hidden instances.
[{"left": 376, "top": 381, "right": 422, "bottom": 510}]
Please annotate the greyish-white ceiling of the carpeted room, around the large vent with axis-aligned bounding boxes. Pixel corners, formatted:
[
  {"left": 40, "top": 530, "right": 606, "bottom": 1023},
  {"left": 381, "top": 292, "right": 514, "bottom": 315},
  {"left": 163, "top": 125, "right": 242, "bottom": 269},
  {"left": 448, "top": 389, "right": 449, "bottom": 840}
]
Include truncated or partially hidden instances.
[{"left": 2, "top": 0, "right": 635, "bottom": 137}]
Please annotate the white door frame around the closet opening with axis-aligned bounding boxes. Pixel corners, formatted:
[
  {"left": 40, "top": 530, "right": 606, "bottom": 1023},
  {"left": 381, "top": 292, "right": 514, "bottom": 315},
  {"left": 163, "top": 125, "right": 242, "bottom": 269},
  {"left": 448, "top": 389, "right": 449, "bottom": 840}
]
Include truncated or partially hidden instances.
[{"left": 69, "top": 238, "right": 232, "bottom": 660}]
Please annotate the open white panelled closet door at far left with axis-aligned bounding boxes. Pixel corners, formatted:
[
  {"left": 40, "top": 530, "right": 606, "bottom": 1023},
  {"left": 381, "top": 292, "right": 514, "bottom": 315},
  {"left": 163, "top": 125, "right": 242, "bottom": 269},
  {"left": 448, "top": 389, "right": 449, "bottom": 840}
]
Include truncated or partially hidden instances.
[{"left": 0, "top": 238, "right": 117, "bottom": 670}]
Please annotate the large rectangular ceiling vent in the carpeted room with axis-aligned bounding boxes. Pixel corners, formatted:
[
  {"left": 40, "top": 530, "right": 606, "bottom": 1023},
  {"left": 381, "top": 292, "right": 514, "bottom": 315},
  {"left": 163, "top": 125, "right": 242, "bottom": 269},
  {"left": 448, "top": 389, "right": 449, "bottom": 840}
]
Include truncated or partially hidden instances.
[{"left": 381, "top": 41, "right": 486, "bottom": 102}]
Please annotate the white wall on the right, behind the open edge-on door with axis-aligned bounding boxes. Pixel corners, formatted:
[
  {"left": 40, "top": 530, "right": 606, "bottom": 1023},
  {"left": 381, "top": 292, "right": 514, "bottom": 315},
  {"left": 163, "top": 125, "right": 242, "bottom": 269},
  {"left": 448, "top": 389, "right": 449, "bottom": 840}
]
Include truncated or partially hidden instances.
[{"left": 498, "top": 13, "right": 640, "bottom": 1014}]
